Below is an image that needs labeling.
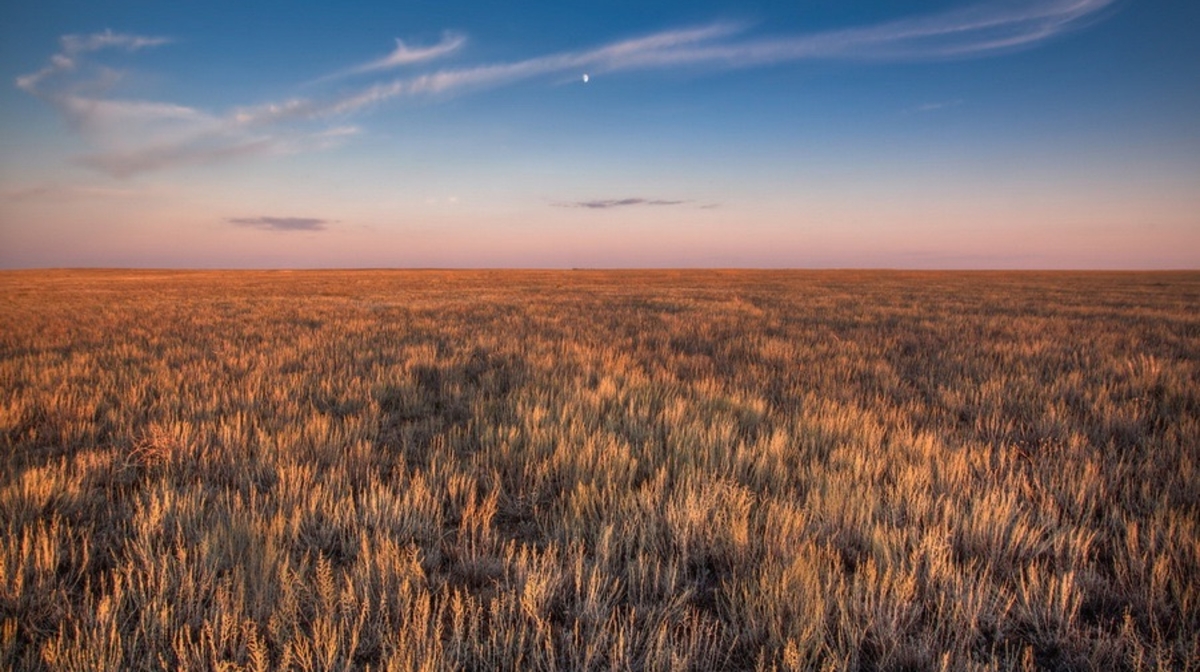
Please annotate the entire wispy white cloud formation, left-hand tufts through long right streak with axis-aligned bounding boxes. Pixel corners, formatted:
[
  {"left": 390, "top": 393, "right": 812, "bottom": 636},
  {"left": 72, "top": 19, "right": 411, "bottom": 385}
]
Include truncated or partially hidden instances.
[{"left": 16, "top": 0, "right": 1116, "bottom": 176}]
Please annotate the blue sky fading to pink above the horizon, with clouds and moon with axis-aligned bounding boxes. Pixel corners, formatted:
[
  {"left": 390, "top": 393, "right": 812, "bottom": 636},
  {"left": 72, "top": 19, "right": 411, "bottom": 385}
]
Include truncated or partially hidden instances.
[{"left": 0, "top": 0, "right": 1200, "bottom": 269}]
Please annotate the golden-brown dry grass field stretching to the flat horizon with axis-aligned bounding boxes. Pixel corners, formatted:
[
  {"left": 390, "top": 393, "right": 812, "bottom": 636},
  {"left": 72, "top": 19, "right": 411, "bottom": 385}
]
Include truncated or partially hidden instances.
[{"left": 0, "top": 271, "right": 1200, "bottom": 670}]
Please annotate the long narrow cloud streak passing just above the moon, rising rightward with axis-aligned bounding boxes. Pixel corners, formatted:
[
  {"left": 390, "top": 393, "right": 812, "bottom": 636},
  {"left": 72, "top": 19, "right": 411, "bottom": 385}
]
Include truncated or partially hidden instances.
[{"left": 306, "top": 0, "right": 1116, "bottom": 115}]
